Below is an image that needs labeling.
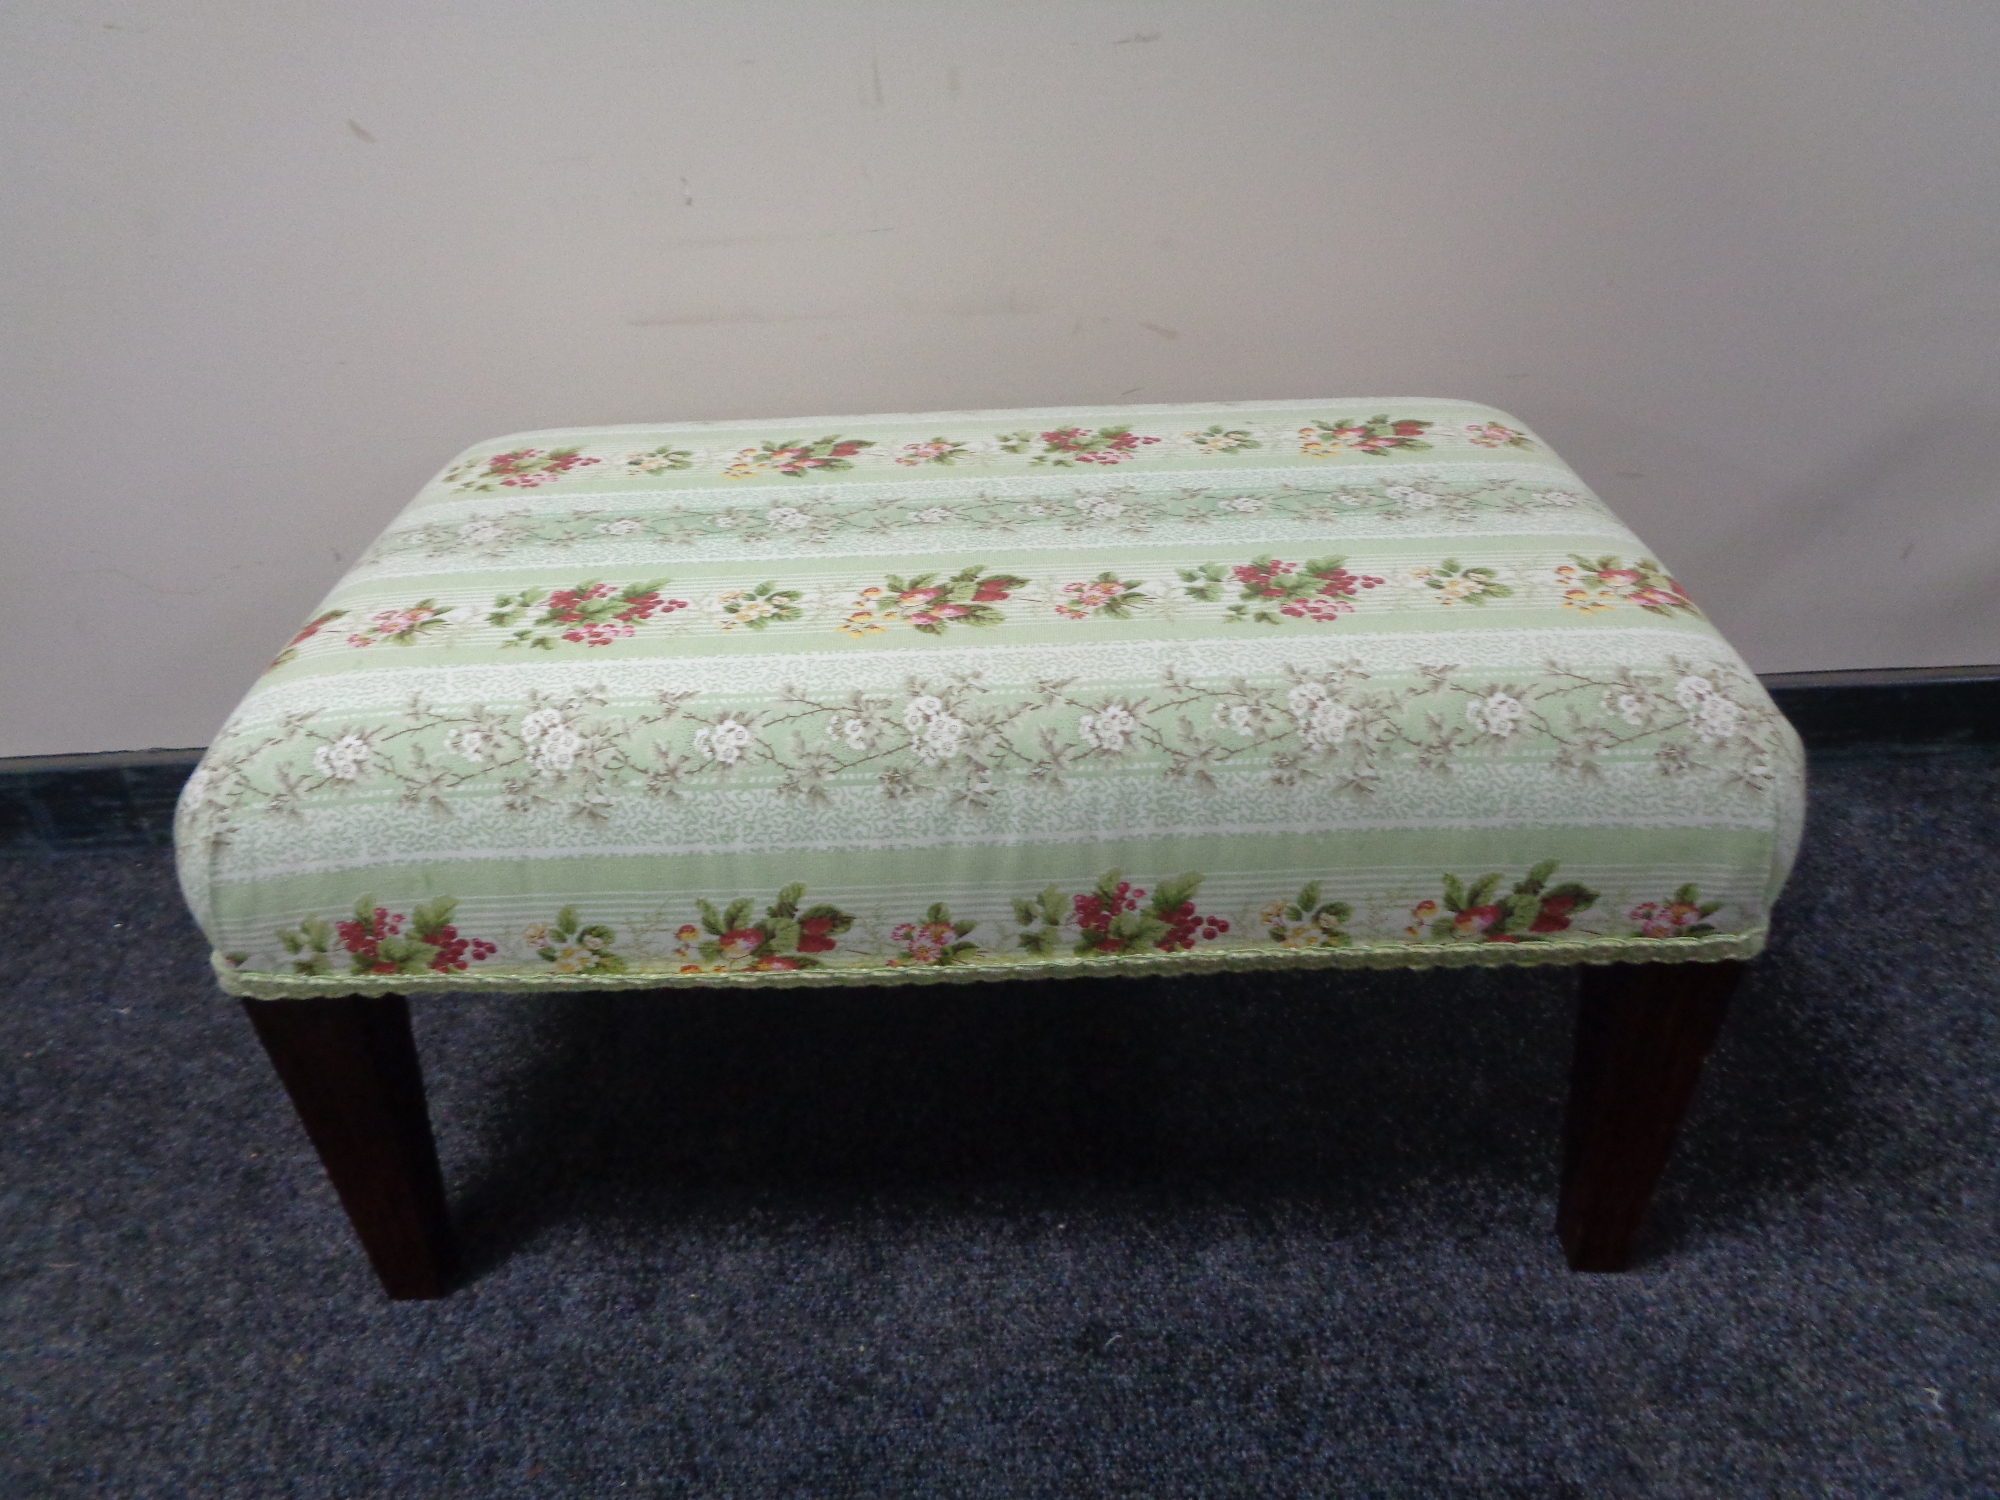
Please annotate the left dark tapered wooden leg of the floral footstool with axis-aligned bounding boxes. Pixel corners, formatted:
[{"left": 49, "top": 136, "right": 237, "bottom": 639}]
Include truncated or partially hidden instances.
[{"left": 244, "top": 994, "right": 456, "bottom": 1300}]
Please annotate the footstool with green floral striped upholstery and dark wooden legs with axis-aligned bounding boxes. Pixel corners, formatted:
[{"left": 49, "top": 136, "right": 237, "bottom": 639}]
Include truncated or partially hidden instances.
[{"left": 176, "top": 398, "right": 1804, "bottom": 1296}]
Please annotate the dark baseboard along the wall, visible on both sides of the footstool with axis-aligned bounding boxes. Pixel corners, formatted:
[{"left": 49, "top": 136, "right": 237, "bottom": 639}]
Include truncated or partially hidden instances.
[{"left": 0, "top": 666, "right": 2000, "bottom": 856}]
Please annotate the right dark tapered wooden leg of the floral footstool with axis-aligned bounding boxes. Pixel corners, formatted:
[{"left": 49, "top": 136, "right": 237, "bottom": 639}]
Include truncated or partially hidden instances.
[{"left": 1556, "top": 962, "right": 1744, "bottom": 1270}]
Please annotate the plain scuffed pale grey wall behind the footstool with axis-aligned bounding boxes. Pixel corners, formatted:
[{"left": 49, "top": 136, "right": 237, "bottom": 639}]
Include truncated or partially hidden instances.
[{"left": 0, "top": 0, "right": 2000, "bottom": 754}]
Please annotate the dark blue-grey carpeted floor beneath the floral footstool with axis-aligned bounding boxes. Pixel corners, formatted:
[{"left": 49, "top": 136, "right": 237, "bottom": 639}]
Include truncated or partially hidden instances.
[{"left": 0, "top": 752, "right": 2000, "bottom": 1500}]
